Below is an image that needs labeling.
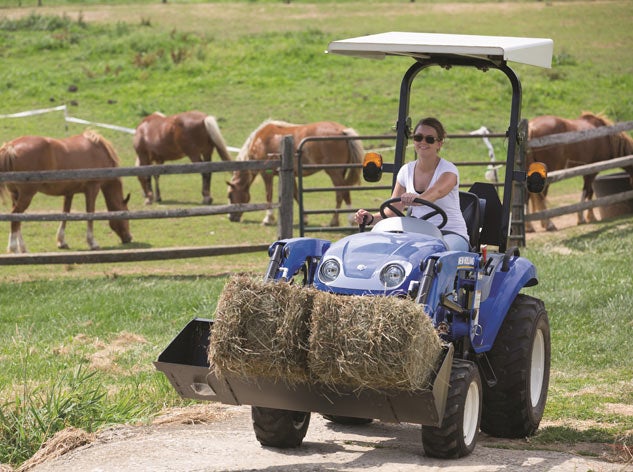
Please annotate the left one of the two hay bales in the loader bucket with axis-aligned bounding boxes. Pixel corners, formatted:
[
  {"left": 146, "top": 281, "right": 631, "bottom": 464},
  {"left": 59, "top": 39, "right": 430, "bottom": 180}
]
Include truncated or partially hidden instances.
[{"left": 209, "top": 275, "right": 316, "bottom": 385}]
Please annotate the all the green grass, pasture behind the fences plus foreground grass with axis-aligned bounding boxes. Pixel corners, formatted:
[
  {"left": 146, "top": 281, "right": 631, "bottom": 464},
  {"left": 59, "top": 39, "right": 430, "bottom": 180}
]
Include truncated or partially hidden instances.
[{"left": 0, "top": 0, "right": 633, "bottom": 465}]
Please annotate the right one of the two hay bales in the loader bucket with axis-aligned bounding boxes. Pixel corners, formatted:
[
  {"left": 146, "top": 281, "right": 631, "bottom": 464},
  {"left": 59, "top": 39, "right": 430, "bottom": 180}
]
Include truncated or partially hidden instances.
[{"left": 308, "top": 292, "right": 441, "bottom": 390}]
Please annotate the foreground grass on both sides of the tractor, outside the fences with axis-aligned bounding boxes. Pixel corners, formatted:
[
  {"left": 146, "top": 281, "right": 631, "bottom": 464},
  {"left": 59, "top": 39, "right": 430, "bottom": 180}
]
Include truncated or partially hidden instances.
[{"left": 0, "top": 218, "right": 633, "bottom": 463}]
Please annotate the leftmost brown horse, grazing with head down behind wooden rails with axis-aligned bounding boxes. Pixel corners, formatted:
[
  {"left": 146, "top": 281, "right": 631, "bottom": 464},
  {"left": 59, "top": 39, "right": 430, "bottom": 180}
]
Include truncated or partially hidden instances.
[{"left": 0, "top": 131, "right": 132, "bottom": 253}]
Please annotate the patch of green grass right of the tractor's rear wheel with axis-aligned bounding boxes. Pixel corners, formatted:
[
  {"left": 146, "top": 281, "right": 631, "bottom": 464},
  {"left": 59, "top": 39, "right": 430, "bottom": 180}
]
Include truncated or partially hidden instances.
[{"left": 522, "top": 217, "right": 633, "bottom": 458}]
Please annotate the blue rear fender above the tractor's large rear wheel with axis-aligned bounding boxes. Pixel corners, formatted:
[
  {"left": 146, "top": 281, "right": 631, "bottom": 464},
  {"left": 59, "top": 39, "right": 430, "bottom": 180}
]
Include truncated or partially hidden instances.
[{"left": 471, "top": 257, "right": 538, "bottom": 353}]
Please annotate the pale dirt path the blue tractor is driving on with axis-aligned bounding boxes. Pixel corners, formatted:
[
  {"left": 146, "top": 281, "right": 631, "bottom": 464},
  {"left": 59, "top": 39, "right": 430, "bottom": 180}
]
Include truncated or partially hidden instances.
[{"left": 25, "top": 404, "right": 633, "bottom": 472}]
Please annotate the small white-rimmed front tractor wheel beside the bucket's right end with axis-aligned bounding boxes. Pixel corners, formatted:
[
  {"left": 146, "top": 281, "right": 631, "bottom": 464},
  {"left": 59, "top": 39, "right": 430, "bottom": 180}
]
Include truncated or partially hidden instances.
[{"left": 422, "top": 359, "right": 482, "bottom": 459}]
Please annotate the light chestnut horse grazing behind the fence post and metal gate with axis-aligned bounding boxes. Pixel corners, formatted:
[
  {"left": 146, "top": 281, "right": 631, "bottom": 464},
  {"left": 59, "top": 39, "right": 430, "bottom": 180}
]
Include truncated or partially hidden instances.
[{"left": 227, "top": 121, "right": 364, "bottom": 226}]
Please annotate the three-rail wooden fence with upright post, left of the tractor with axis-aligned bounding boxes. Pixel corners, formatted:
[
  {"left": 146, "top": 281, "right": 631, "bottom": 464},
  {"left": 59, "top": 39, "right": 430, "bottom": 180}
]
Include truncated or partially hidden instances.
[{"left": 0, "top": 136, "right": 294, "bottom": 265}]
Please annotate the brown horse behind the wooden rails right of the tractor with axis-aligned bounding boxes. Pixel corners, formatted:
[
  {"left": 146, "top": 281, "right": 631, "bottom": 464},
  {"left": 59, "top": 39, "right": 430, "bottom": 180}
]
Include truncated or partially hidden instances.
[{"left": 526, "top": 112, "right": 633, "bottom": 231}]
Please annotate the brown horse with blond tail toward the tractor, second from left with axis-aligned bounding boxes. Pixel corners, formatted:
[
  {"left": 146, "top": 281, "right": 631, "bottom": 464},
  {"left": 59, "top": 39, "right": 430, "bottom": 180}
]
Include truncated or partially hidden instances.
[{"left": 134, "top": 111, "right": 231, "bottom": 205}]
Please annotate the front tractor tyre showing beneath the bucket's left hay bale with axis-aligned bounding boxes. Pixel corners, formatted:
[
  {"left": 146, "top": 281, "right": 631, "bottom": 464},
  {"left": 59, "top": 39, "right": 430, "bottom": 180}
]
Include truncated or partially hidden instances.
[{"left": 251, "top": 406, "right": 310, "bottom": 449}]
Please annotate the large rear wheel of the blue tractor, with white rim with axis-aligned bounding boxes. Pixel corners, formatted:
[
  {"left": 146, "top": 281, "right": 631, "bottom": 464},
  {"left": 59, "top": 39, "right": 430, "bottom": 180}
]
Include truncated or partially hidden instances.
[{"left": 481, "top": 294, "right": 551, "bottom": 438}]
